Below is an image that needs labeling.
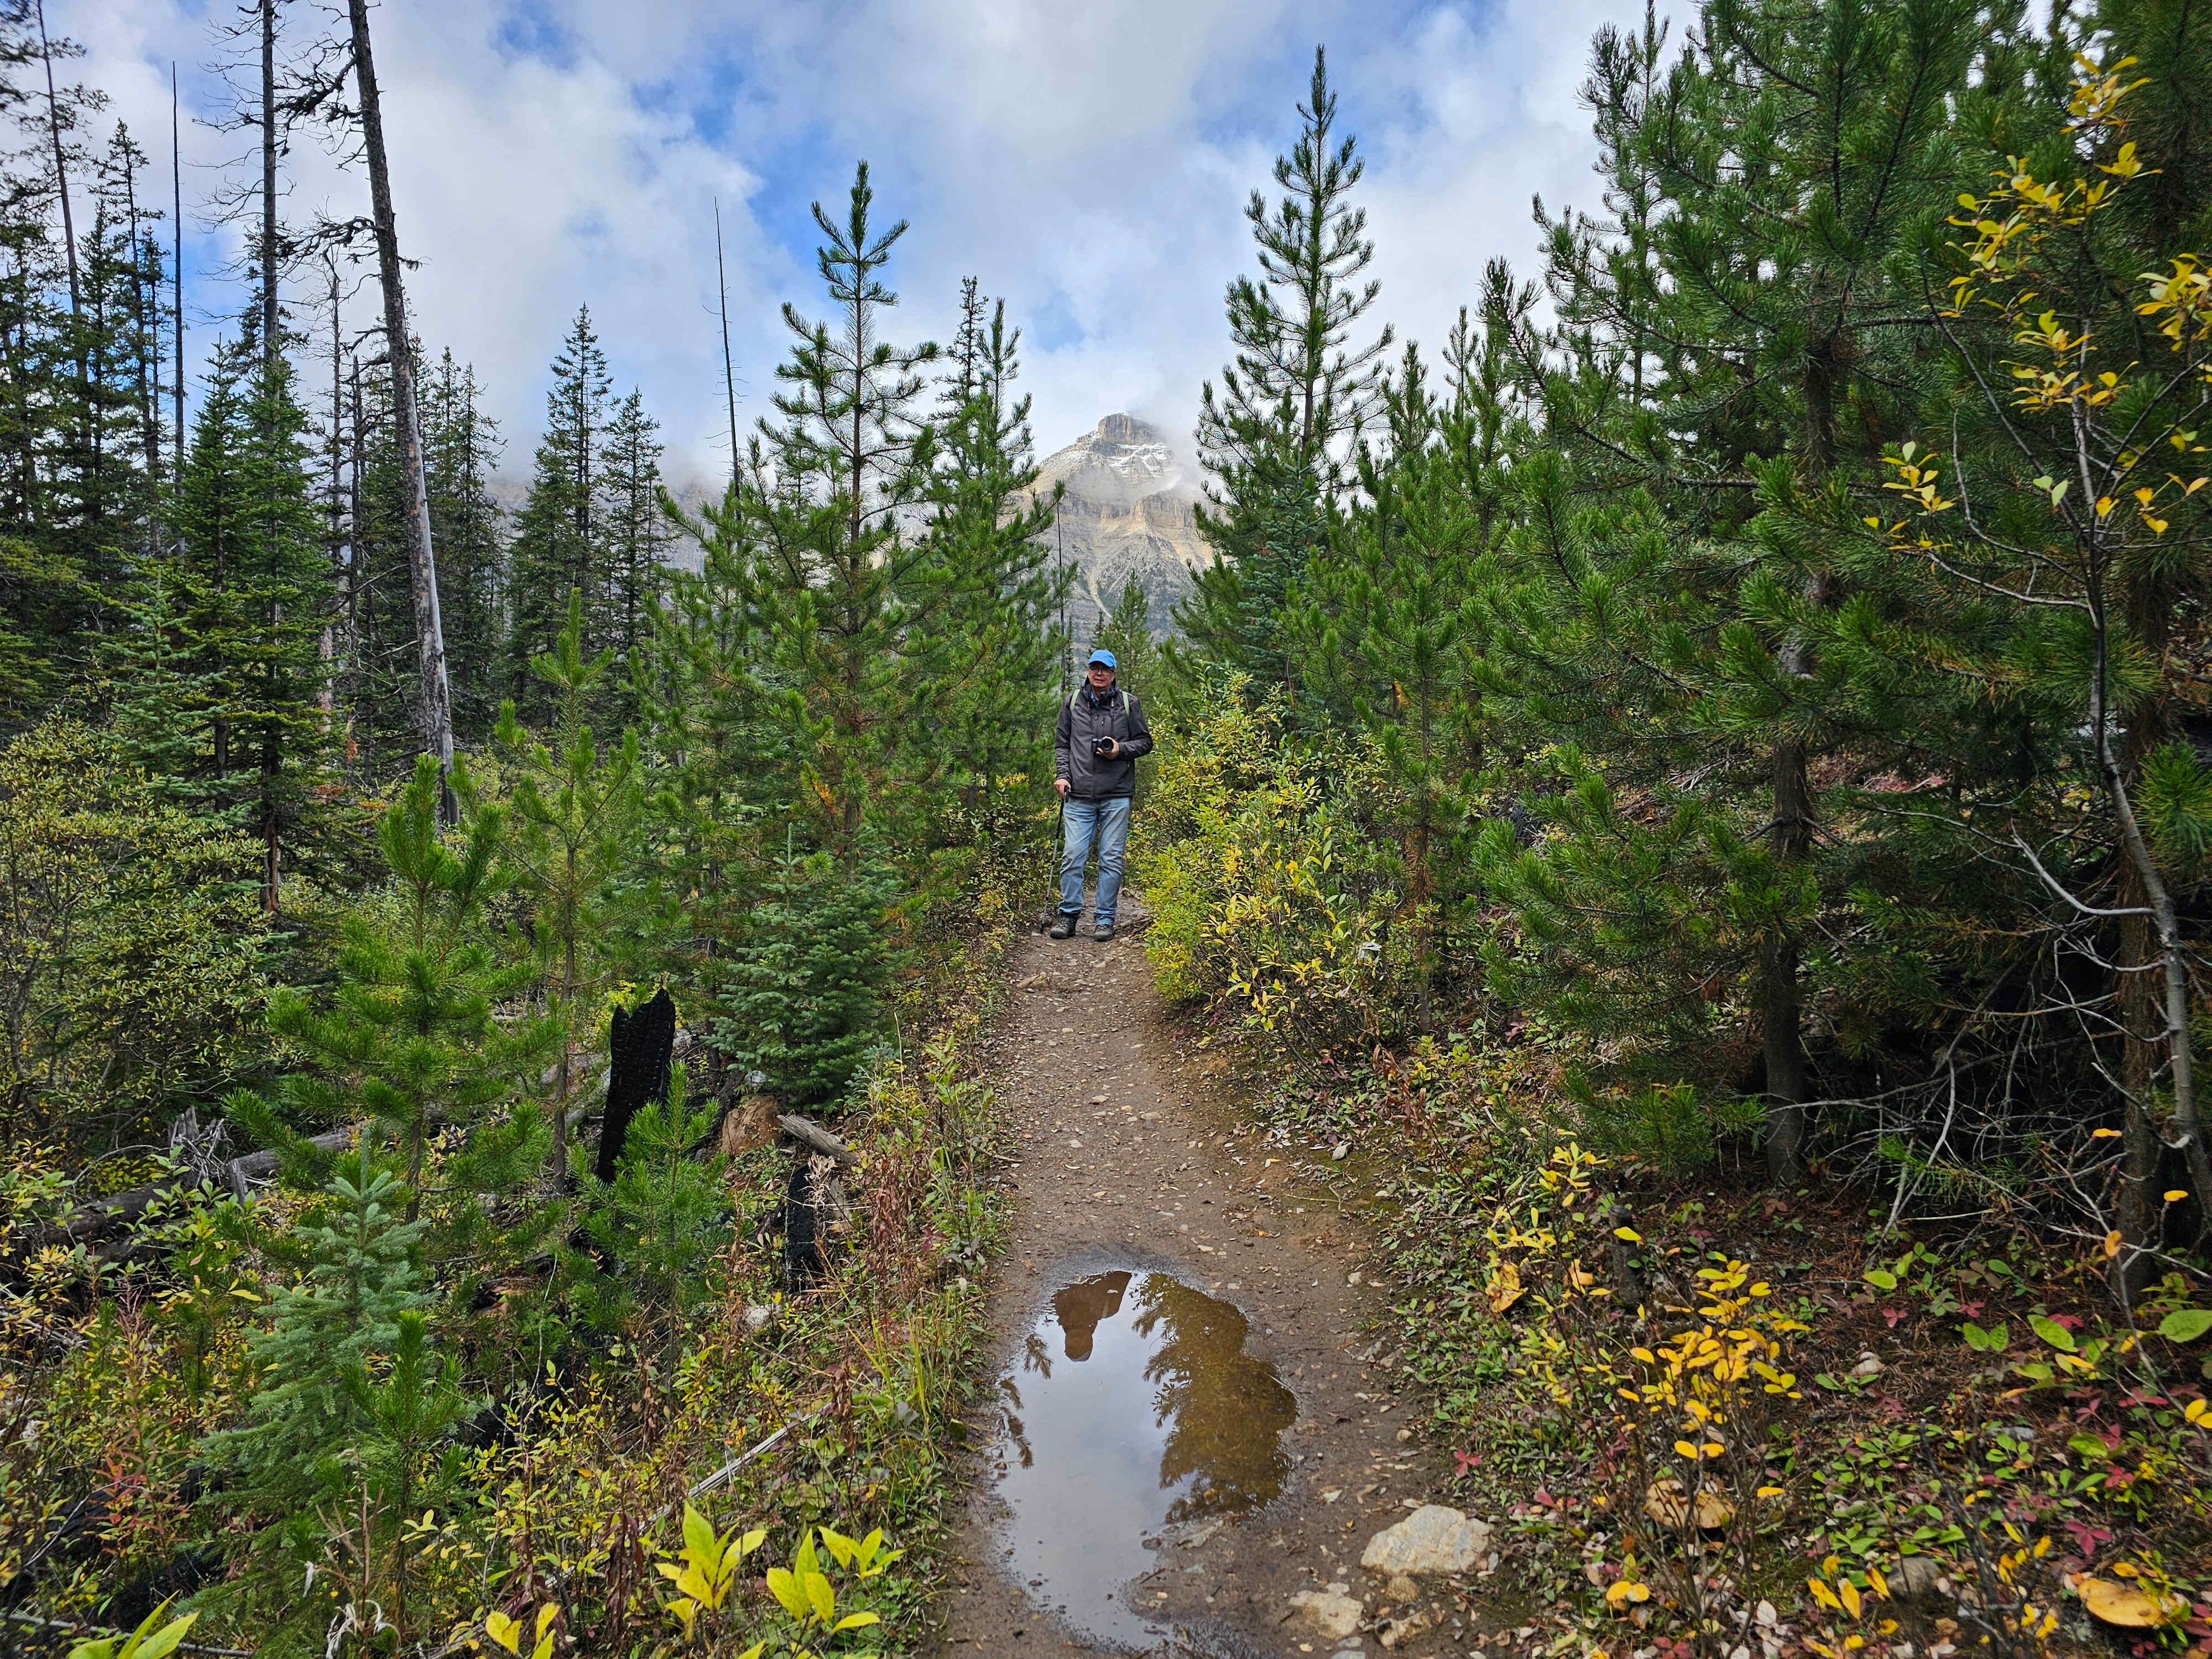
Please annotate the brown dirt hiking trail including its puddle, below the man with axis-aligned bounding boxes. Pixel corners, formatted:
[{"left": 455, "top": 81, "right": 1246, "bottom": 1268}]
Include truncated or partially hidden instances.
[{"left": 936, "top": 929, "right": 1480, "bottom": 1655}]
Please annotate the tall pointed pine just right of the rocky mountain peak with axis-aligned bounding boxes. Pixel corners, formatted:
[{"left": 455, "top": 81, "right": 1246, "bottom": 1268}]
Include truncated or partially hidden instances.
[{"left": 1179, "top": 49, "right": 1391, "bottom": 697}]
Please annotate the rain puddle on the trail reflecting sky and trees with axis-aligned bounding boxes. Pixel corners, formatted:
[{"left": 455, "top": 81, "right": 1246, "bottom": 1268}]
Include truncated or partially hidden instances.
[{"left": 998, "top": 1272, "right": 1298, "bottom": 1646}]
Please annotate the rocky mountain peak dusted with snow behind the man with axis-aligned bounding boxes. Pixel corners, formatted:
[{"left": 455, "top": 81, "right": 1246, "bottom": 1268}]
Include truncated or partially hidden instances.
[{"left": 1037, "top": 414, "right": 1212, "bottom": 646}]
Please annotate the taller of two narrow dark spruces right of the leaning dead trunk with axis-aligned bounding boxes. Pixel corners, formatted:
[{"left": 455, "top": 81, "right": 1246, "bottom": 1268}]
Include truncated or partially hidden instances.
[{"left": 507, "top": 305, "right": 611, "bottom": 723}]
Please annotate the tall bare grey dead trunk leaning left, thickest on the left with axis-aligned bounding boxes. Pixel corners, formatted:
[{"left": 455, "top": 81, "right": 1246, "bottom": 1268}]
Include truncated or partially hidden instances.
[{"left": 347, "top": 0, "right": 458, "bottom": 823}]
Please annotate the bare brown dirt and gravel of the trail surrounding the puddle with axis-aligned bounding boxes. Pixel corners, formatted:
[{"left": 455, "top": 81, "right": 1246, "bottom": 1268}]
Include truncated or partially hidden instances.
[{"left": 931, "top": 929, "right": 1484, "bottom": 1659}]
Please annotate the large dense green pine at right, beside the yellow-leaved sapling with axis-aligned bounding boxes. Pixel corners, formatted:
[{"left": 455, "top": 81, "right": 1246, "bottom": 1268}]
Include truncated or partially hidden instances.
[{"left": 1493, "top": 0, "right": 2024, "bottom": 1181}]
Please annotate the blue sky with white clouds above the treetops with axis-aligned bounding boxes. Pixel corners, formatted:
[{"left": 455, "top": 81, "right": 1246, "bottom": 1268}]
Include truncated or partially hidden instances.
[{"left": 49, "top": 0, "right": 1641, "bottom": 487}]
